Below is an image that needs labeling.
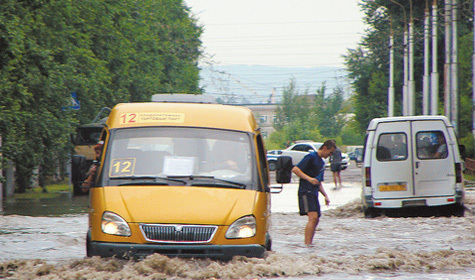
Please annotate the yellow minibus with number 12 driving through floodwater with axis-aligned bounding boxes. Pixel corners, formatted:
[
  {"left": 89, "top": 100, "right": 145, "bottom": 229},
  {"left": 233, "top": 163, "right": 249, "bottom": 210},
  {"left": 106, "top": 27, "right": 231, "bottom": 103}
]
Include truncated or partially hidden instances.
[{"left": 87, "top": 94, "right": 271, "bottom": 259}]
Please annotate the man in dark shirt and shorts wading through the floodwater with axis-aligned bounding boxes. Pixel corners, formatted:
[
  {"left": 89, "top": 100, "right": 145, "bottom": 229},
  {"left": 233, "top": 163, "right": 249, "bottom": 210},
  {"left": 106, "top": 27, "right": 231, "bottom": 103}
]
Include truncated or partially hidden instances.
[{"left": 292, "top": 140, "right": 336, "bottom": 245}]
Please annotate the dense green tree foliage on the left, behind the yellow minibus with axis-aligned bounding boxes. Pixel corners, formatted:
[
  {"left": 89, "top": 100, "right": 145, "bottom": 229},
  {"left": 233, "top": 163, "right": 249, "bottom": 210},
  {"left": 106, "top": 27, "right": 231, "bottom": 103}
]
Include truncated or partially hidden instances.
[{"left": 0, "top": 0, "right": 202, "bottom": 192}]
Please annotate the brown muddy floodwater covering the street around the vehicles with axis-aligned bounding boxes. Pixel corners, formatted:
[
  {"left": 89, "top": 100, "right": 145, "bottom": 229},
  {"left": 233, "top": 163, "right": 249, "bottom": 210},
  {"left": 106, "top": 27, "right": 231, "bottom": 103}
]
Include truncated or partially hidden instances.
[{"left": 0, "top": 163, "right": 475, "bottom": 279}]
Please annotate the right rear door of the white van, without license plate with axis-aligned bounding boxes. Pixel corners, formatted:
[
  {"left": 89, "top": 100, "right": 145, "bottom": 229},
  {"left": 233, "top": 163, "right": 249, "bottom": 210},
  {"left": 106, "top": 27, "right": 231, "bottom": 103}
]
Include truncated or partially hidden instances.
[{"left": 412, "top": 120, "right": 455, "bottom": 196}]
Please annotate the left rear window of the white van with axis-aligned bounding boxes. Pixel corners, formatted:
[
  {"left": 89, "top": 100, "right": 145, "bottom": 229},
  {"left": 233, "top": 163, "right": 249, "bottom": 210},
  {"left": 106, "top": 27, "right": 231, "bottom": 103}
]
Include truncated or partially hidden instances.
[{"left": 376, "top": 133, "right": 407, "bottom": 161}]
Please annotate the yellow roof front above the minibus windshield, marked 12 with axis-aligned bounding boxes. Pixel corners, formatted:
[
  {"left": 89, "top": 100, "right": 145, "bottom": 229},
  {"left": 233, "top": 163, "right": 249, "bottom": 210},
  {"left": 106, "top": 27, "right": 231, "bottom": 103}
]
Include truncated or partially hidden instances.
[{"left": 106, "top": 102, "right": 257, "bottom": 132}]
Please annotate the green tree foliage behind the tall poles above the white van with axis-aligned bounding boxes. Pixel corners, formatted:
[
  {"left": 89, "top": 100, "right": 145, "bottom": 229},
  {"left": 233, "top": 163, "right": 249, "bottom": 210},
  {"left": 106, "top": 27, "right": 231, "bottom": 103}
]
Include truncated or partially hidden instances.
[{"left": 345, "top": 0, "right": 473, "bottom": 155}]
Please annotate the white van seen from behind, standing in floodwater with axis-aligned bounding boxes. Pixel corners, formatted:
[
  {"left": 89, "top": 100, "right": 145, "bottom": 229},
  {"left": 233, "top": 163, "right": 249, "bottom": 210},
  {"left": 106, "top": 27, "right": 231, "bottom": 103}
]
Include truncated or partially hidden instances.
[{"left": 362, "top": 116, "right": 464, "bottom": 217}]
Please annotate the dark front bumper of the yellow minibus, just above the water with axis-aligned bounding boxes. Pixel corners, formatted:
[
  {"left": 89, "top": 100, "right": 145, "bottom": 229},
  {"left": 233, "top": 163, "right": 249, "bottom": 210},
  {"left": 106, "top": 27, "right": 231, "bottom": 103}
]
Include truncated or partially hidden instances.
[{"left": 89, "top": 241, "right": 266, "bottom": 260}]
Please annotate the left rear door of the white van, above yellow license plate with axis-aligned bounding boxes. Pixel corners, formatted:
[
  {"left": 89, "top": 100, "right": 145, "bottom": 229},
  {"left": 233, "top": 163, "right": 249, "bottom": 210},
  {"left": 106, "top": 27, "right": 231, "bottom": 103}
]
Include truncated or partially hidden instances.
[{"left": 371, "top": 122, "right": 413, "bottom": 199}]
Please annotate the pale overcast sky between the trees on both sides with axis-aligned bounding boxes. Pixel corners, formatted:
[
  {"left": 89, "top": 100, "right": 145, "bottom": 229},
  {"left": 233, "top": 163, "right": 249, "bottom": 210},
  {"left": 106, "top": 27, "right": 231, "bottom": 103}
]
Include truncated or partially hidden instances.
[{"left": 185, "top": 0, "right": 365, "bottom": 67}]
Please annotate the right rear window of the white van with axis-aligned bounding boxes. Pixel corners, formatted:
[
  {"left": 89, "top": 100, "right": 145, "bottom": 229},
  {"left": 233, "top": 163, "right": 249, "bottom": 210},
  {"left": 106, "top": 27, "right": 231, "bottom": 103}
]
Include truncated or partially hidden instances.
[{"left": 416, "top": 130, "right": 448, "bottom": 159}]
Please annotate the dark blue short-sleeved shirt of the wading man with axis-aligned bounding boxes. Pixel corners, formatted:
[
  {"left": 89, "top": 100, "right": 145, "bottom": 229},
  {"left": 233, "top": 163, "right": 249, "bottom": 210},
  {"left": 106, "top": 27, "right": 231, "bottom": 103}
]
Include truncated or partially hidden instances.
[{"left": 297, "top": 152, "right": 325, "bottom": 193}]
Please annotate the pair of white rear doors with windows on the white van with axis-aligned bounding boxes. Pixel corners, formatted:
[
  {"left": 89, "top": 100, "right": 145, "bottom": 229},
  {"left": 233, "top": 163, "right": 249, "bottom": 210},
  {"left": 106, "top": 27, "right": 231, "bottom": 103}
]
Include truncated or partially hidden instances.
[{"left": 371, "top": 120, "right": 456, "bottom": 199}]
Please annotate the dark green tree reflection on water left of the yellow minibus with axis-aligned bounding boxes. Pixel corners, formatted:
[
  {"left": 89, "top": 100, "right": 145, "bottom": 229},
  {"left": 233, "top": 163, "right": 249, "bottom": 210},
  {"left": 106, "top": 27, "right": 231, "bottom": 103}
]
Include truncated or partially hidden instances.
[{"left": 0, "top": 192, "right": 89, "bottom": 217}]
